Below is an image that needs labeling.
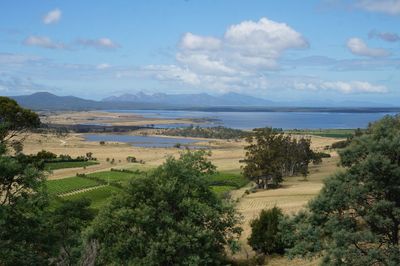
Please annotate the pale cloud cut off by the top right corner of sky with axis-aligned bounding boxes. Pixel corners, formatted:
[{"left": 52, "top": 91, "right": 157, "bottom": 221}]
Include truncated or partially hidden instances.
[{"left": 356, "top": 0, "right": 400, "bottom": 15}]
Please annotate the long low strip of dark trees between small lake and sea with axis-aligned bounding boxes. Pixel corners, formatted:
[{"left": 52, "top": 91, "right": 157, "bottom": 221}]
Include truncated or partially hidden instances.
[{"left": 161, "top": 125, "right": 249, "bottom": 140}]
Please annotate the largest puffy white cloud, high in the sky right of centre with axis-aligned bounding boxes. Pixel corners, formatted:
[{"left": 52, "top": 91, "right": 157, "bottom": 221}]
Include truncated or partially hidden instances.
[{"left": 176, "top": 18, "right": 308, "bottom": 78}]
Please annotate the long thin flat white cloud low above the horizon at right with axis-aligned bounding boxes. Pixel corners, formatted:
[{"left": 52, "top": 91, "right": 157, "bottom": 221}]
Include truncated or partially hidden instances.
[{"left": 293, "top": 81, "right": 388, "bottom": 94}]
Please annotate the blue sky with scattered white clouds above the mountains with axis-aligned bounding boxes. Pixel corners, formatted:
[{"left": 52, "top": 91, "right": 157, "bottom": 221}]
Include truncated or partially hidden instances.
[{"left": 0, "top": 0, "right": 400, "bottom": 106}]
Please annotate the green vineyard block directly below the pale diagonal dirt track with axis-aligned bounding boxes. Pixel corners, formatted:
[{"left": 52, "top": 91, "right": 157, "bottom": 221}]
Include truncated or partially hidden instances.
[{"left": 63, "top": 186, "right": 120, "bottom": 209}]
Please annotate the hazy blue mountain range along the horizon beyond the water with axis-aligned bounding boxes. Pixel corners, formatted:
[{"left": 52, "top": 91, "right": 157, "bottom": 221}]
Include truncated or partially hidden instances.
[{"left": 7, "top": 92, "right": 392, "bottom": 111}]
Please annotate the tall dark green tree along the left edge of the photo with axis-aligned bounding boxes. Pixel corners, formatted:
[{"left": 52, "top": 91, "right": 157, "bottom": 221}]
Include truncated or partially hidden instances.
[{"left": 0, "top": 97, "right": 54, "bottom": 265}]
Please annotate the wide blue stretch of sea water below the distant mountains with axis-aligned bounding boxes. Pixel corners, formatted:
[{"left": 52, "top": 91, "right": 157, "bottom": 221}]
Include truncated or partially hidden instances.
[{"left": 110, "top": 110, "right": 395, "bottom": 129}]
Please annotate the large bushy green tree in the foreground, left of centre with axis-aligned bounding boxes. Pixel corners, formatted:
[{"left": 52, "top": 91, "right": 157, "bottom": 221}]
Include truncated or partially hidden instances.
[{"left": 87, "top": 151, "right": 241, "bottom": 265}]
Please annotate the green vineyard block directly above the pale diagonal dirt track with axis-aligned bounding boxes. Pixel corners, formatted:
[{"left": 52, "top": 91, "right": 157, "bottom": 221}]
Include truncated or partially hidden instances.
[{"left": 47, "top": 177, "right": 101, "bottom": 195}]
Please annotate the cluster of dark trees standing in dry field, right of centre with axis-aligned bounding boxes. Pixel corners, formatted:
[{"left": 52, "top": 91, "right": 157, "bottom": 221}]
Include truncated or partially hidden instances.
[{"left": 243, "top": 128, "right": 315, "bottom": 188}]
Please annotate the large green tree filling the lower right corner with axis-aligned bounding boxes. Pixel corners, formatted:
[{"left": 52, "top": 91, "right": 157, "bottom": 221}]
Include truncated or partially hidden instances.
[{"left": 290, "top": 115, "right": 400, "bottom": 265}]
